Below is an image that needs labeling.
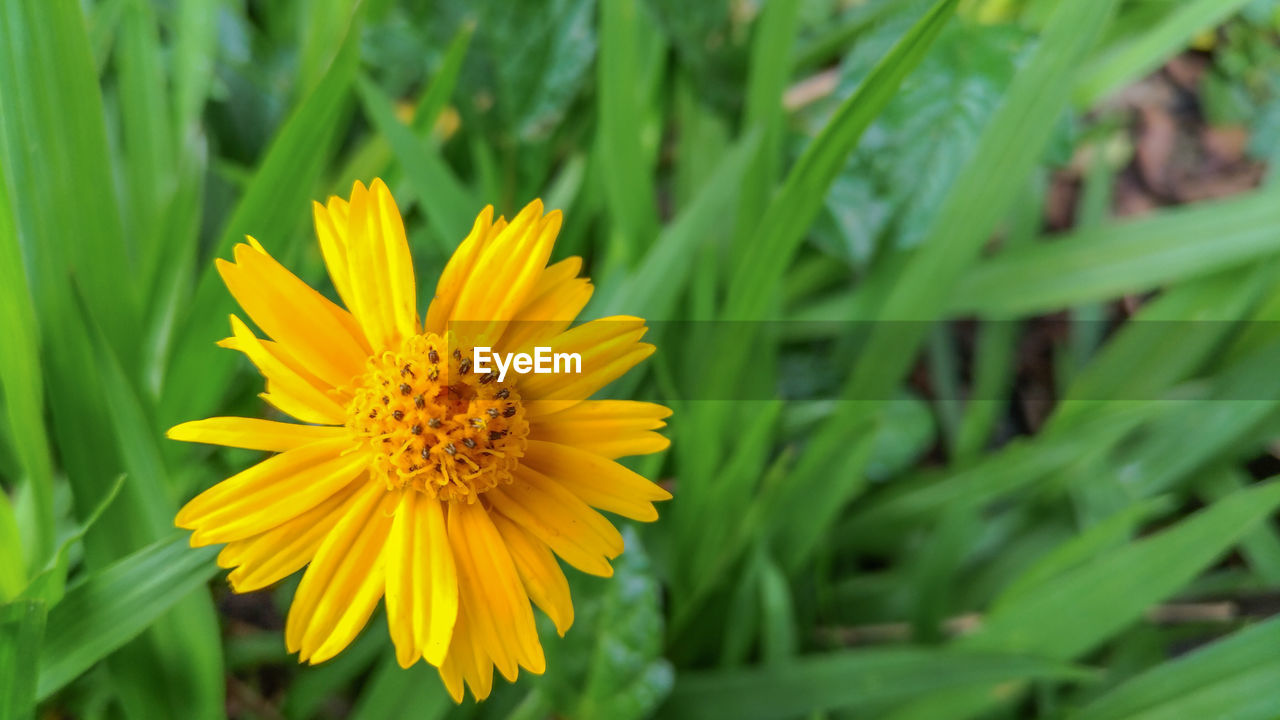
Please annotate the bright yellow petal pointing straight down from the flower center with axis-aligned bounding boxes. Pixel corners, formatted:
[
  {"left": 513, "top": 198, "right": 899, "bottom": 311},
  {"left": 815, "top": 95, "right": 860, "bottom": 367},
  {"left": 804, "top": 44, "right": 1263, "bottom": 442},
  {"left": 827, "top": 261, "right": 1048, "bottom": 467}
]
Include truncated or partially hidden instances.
[{"left": 387, "top": 492, "right": 458, "bottom": 667}]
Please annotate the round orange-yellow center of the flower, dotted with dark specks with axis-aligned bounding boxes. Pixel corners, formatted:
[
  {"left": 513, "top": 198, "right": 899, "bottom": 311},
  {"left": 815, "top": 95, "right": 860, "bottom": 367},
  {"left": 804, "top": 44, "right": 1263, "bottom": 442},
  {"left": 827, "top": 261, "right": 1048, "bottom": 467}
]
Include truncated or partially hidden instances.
[{"left": 347, "top": 333, "right": 529, "bottom": 502}]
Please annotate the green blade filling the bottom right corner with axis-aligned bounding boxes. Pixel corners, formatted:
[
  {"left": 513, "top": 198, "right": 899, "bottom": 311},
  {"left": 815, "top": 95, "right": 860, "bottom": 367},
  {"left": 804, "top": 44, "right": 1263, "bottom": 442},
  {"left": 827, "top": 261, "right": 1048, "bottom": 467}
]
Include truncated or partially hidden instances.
[{"left": 1071, "top": 609, "right": 1280, "bottom": 720}]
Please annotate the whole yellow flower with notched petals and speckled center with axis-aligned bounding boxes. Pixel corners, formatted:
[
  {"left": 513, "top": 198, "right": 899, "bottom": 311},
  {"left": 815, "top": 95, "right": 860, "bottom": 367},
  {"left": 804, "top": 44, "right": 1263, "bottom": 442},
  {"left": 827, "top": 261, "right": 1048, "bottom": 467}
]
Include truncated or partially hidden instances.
[{"left": 169, "top": 179, "right": 671, "bottom": 702}]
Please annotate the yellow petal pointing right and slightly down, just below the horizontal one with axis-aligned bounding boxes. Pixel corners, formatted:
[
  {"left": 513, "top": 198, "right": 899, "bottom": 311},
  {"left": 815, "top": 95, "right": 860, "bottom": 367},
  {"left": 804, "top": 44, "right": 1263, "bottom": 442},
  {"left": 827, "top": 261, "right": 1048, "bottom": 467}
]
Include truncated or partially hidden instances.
[{"left": 522, "top": 441, "right": 671, "bottom": 523}]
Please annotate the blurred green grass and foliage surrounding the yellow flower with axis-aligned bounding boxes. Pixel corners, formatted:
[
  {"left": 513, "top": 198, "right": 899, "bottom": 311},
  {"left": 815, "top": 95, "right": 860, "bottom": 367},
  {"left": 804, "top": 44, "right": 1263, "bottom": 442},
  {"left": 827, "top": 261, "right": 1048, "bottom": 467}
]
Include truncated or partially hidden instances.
[{"left": 0, "top": 0, "right": 1280, "bottom": 720}]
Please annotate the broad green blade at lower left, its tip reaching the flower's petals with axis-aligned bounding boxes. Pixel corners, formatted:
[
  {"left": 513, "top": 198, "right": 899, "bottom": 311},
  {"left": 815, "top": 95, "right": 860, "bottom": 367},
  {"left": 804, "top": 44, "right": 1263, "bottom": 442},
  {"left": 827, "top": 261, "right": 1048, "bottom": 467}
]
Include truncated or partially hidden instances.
[{"left": 36, "top": 532, "right": 218, "bottom": 700}]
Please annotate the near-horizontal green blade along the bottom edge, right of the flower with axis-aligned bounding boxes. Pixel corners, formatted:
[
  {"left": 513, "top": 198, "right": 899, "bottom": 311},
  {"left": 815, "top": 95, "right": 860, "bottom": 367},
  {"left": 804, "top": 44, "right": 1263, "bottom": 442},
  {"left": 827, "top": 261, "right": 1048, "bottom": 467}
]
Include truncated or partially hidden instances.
[{"left": 660, "top": 648, "right": 1089, "bottom": 720}]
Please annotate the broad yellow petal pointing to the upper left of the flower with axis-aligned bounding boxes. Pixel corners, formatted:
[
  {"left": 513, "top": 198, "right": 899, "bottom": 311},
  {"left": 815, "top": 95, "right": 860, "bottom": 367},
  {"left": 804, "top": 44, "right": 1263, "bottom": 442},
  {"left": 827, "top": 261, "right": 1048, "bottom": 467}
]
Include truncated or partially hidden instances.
[{"left": 218, "top": 245, "right": 370, "bottom": 387}]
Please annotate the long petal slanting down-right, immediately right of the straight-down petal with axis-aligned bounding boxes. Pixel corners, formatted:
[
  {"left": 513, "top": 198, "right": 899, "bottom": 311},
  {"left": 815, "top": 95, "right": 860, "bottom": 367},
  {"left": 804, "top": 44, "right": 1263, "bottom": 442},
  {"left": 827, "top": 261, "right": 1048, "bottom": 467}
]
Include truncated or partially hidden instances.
[{"left": 448, "top": 502, "right": 547, "bottom": 680}]
